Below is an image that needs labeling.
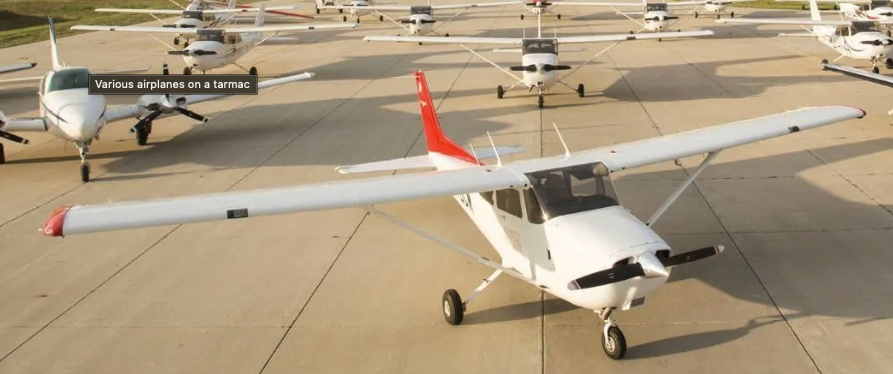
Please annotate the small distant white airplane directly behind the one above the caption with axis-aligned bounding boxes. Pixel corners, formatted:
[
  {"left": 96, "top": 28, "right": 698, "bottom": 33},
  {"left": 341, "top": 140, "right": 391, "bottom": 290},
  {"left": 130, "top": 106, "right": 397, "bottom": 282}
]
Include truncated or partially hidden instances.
[{"left": 96, "top": 0, "right": 298, "bottom": 47}]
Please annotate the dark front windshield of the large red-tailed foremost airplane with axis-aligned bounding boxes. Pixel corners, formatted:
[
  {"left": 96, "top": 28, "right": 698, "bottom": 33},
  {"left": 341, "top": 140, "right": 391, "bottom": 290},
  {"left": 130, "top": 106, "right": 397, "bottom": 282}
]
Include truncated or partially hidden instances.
[{"left": 527, "top": 162, "right": 620, "bottom": 220}]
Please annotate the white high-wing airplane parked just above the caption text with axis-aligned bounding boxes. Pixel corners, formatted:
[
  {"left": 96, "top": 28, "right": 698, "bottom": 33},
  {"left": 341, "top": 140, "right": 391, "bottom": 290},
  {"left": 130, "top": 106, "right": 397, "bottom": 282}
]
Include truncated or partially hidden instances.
[{"left": 71, "top": 4, "right": 358, "bottom": 75}]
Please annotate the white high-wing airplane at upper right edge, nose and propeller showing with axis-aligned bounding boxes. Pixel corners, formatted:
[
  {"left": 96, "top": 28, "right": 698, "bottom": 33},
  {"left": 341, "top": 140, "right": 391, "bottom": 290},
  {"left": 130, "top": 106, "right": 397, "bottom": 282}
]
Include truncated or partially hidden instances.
[{"left": 716, "top": 0, "right": 893, "bottom": 73}]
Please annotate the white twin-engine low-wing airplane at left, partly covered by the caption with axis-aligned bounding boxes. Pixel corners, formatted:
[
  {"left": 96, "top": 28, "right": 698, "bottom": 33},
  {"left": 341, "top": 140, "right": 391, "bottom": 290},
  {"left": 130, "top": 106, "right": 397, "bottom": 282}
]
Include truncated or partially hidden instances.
[{"left": 0, "top": 17, "right": 313, "bottom": 182}]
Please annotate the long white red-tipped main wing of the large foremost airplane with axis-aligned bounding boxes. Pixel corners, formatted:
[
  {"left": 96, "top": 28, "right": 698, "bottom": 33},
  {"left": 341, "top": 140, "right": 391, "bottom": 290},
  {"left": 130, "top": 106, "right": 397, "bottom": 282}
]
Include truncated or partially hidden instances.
[{"left": 42, "top": 106, "right": 865, "bottom": 236}]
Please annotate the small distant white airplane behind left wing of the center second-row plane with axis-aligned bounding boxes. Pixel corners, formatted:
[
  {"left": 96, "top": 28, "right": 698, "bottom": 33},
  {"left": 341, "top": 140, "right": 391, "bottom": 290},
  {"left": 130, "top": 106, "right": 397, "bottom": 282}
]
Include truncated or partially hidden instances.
[{"left": 320, "top": 1, "right": 518, "bottom": 36}]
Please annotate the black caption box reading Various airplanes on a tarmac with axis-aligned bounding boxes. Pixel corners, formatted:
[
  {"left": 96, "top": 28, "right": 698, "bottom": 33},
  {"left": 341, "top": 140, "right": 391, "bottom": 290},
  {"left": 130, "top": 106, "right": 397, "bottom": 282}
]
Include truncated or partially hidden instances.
[{"left": 87, "top": 74, "right": 257, "bottom": 95}]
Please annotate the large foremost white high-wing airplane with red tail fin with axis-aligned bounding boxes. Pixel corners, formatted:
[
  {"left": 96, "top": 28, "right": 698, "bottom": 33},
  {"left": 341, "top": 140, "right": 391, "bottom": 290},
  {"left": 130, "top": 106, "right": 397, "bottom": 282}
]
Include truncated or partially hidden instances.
[{"left": 42, "top": 72, "right": 865, "bottom": 359}]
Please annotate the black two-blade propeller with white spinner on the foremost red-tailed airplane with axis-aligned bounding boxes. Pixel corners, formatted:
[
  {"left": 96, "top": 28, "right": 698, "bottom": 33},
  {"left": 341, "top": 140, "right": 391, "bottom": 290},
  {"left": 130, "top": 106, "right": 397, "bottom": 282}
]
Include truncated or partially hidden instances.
[{"left": 567, "top": 245, "right": 724, "bottom": 290}]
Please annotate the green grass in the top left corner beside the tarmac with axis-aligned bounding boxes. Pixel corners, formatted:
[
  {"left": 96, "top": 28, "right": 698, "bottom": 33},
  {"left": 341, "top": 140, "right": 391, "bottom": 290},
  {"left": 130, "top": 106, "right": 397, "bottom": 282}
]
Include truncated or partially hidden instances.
[{"left": 0, "top": 0, "right": 250, "bottom": 48}]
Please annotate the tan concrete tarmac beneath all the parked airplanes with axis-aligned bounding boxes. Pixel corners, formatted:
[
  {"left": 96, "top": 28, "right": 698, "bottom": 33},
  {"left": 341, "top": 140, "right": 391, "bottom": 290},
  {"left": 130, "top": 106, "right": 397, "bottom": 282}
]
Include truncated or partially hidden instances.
[{"left": 0, "top": 0, "right": 893, "bottom": 374}]
